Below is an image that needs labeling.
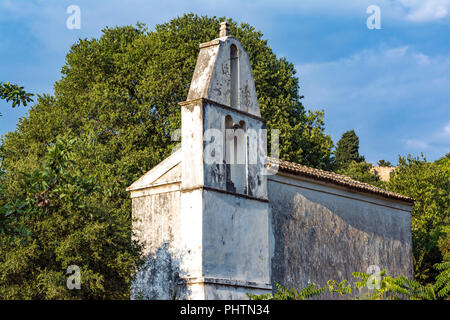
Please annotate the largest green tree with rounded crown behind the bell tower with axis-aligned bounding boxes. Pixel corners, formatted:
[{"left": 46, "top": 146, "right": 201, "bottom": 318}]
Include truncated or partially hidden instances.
[{"left": 3, "top": 14, "right": 332, "bottom": 205}]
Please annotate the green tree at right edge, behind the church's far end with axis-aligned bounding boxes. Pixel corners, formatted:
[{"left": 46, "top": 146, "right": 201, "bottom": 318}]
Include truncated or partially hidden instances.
[{"left": 387, "top": 156, "right": 450, "bottom": 283}]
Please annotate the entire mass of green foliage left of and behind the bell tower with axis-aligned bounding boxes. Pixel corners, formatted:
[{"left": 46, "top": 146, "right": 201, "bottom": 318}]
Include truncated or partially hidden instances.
[{"left": 0, "top": 14, "right": 333, "bottom": 298}]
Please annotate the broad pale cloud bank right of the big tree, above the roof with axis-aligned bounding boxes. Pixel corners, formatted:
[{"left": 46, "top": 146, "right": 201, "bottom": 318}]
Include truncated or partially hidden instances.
[{"left": 296, "top": 46, "right": 450, "bottom": 158}]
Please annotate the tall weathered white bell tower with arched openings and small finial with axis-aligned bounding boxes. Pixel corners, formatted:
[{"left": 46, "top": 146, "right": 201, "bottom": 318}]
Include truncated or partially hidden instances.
[{"left": 180, "top": 22, "right": 272, "bottom": 299}]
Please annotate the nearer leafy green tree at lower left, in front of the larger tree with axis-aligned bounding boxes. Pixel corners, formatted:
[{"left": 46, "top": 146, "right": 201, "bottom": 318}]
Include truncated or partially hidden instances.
[{"left": 0, "top": 139, "right": 140, "bottom": 300}]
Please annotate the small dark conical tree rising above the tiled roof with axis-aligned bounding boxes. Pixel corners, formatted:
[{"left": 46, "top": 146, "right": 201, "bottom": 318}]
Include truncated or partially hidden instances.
[{"left": 335, "top": 130, "right": 364, "bottom": 169}]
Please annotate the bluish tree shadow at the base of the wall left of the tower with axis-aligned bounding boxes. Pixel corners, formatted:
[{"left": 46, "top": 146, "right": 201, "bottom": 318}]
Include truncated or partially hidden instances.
[{"left": 131, "top": 242, "right": 190, "bottom": 300}]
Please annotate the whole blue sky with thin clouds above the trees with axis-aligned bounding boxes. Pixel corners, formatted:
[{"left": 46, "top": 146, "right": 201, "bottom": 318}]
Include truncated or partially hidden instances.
[{"left": 0, "top": 0, "right": 450, "bottom": 163}]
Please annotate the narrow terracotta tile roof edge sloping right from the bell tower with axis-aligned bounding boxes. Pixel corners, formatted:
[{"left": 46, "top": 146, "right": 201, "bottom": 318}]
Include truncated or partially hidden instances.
[{"left": 268, "top": 158, "right": 414, "bottom": 203}]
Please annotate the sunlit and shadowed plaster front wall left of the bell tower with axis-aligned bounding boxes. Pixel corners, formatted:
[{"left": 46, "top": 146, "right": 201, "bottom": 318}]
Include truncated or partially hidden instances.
[{"left": 131, "top": 191, "right": 182, "bottom": 300}]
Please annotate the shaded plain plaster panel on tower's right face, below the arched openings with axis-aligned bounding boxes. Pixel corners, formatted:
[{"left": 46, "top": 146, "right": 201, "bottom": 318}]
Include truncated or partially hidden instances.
[{"left": 203, "top": 190, "right": 270, "bottom": 284}]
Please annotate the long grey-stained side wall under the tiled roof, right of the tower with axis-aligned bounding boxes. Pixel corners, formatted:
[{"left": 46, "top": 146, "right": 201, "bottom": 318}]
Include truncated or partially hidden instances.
[{"left": 268, "top": 175, "right": 412, "bottom": 298}]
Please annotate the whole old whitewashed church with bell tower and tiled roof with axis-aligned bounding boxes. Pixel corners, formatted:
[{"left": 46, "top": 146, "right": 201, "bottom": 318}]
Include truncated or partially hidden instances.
[{"left": 127, "top": 23, "right": 413, "bottom": 299}]
